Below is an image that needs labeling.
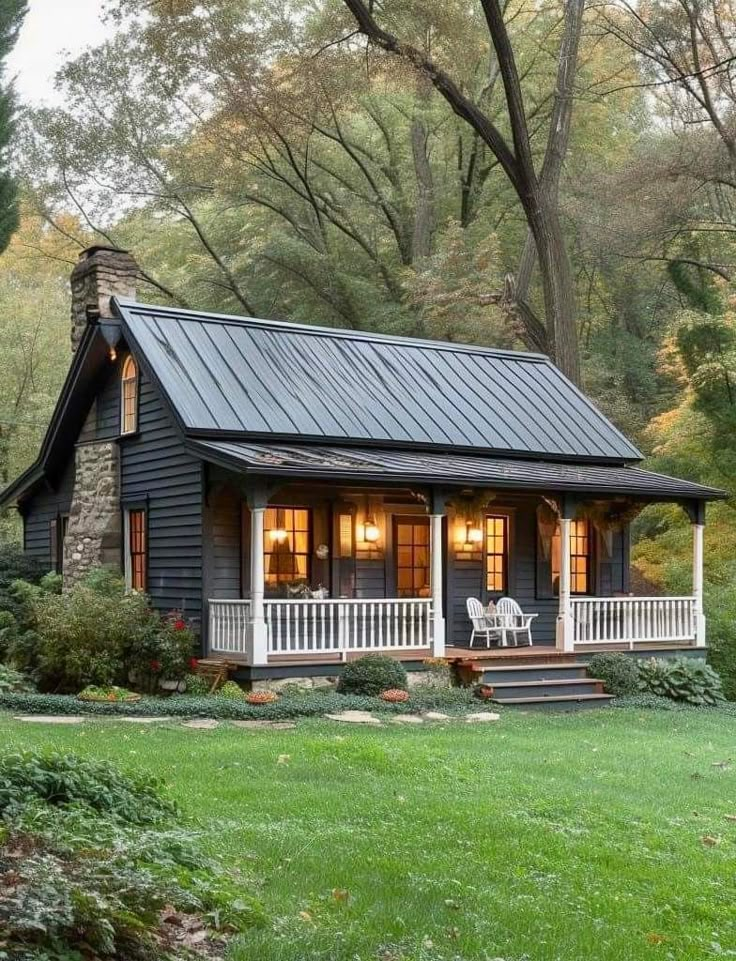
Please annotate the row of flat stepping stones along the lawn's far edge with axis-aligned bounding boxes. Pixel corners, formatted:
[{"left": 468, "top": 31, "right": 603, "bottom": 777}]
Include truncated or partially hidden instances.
[{"left": 8, "top": 711, "right": 501, "bottom": 731}]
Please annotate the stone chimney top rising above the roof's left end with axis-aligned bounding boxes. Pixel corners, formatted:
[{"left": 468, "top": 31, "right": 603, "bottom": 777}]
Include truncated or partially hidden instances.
[{"left": 71, "top": 245, "right": 139, "bottom": 353}]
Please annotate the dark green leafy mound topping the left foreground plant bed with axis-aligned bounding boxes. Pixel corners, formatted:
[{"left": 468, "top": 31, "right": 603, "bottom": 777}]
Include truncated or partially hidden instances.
[{"left": 0, "top": 751, "right": 176, "bottom": 824}]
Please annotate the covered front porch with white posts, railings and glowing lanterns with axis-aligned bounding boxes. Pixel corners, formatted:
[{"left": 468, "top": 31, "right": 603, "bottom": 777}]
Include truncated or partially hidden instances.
[{"left": 197, "top": 444, "right": 705, "bottom": 668}]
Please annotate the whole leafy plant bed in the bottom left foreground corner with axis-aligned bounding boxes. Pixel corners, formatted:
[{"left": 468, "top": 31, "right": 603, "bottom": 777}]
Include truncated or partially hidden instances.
[{"left": 0, "top": 752, "right": 263, "bottom": 961}]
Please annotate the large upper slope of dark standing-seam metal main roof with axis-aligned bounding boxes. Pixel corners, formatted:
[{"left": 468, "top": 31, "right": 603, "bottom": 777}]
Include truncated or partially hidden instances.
[{"left": 116, "top": 300, "right": 641, "bottom": 461}]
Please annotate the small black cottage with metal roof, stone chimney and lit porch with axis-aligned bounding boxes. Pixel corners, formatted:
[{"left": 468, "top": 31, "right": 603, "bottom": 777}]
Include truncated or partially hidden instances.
[{"left": 0, "top": 247, "right": 721, "bottom": 675}]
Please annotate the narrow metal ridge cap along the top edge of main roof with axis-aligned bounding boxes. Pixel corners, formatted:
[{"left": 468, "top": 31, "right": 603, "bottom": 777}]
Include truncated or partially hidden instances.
[{"left": 112, "top": 297, "right": 552, "bottom": 364}]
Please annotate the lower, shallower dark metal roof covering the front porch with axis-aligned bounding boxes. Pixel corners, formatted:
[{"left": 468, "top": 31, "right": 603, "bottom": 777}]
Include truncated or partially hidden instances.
[{"left": 189, "top": 441, "right": 726, "bottom": 500}]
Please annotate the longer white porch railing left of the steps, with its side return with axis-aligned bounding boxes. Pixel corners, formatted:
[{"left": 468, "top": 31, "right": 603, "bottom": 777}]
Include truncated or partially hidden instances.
[{"left": 209, "top": 598, "right": 432, "bottom": 658}]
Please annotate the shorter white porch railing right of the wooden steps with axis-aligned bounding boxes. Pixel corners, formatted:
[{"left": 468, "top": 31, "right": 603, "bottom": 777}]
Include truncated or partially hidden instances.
[{"left": 570, "top": 597, "right": 696, "bottom": 649}]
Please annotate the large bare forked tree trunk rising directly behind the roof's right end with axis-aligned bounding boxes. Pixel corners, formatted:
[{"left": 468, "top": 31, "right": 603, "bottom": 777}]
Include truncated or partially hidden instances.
[{"left": 343, "top": 0, "right": 585, "bottom": 382}]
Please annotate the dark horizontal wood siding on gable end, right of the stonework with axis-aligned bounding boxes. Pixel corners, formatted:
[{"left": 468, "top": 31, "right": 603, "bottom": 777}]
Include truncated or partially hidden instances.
[{"left": 120, "top": 371, "right": 203, "bottom": 624}]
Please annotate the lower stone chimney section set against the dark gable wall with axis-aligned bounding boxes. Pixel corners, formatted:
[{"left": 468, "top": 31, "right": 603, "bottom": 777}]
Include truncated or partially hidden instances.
[{"left": 64, "top": 441, "right": 122, "bottom": 588}]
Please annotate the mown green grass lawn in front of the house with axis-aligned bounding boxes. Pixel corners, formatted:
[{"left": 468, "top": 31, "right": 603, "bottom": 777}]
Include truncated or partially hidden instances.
[{"left": 0, "top": 710, "right": 736, "bottom": 961}]
